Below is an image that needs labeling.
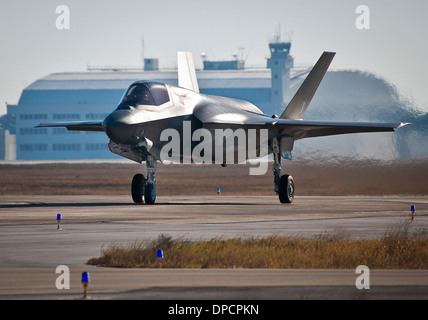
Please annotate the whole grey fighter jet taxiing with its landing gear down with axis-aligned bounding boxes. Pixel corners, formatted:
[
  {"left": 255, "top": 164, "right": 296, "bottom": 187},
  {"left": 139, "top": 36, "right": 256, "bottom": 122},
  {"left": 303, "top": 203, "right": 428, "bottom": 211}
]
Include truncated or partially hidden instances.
[{"left": 37, "top": 52, "right": 407, "bottom": 204}]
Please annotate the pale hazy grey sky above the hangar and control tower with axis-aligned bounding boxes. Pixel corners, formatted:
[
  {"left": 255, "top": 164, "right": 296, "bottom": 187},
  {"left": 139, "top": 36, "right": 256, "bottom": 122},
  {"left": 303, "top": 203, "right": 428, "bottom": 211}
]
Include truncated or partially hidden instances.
[{"left": 0, "top": 0, "right": 428, "bottom": 114}]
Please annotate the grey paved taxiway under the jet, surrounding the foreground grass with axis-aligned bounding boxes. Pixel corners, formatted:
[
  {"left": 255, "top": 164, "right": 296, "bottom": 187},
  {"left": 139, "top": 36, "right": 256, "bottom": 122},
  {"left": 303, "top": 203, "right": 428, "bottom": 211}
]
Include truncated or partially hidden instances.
[{"left": 0, "top": 196, "right": 428, "bottom": 299}]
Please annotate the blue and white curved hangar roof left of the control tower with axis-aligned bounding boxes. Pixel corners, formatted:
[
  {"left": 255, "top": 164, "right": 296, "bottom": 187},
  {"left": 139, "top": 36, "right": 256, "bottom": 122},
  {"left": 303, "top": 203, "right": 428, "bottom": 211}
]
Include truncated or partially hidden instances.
[{"left": 18, "top": 69, "right": 271, "bottom": 105}]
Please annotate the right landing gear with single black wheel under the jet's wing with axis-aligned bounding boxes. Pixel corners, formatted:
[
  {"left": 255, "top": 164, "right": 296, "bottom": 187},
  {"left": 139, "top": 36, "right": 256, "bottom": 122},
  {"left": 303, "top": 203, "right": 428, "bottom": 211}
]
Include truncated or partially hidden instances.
[{"left": 272, "top": 138, "right": 294, "bottom": 203}]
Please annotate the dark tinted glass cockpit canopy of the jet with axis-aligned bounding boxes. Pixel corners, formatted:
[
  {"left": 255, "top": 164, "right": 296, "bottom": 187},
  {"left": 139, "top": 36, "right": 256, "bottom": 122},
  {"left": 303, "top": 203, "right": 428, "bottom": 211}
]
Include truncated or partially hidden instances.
[{"left": 119, "top": 81, "right": 169, "bottom": 106}]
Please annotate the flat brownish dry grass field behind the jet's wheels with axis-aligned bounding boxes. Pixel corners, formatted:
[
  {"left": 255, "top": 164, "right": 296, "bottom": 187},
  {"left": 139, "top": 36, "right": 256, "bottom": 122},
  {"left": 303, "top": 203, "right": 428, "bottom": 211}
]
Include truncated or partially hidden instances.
[{"left": 0, "top": 159, "right": 428, "bottom": 196}]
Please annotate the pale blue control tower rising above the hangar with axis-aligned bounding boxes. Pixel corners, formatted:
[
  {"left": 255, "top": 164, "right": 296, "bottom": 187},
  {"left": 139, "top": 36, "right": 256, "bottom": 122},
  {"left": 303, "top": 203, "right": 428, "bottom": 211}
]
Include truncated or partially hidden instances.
[{"left": 267, "top": 36, "right": 294, "bottom": 110}]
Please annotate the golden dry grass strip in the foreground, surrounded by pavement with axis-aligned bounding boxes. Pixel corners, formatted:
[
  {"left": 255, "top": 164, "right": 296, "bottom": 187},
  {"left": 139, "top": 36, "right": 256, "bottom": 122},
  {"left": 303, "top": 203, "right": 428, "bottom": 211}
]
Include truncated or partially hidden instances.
[{"left": 87, "top": 224, "right": 428, "bottom": 269}]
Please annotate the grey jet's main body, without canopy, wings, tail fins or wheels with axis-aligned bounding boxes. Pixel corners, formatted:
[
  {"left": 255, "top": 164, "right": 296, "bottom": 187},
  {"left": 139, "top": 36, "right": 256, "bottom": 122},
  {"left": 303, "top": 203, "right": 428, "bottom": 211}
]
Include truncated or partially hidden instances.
[{"left": 103, "top": 81, "right": 267, "bottom": 164}]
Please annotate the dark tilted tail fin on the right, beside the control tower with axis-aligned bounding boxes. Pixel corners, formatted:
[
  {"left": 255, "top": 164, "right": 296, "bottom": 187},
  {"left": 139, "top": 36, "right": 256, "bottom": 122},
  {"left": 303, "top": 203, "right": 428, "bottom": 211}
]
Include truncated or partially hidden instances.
[{"left": 280, "top": 52, "right": 336, "bottom": 120}]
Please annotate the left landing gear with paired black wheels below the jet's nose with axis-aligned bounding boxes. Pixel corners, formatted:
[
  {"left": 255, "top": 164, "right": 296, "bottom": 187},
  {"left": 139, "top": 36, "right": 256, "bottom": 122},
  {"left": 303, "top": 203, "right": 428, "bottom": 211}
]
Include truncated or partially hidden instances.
[{"left": 131, "top": 155, "right": 156, "bottom": 204}]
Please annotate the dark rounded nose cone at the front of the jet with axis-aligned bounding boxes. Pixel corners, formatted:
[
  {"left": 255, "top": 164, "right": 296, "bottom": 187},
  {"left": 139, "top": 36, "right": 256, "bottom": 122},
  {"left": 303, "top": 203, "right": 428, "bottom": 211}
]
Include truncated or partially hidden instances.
[{"left": 103, "top": 110, "right": 138, "bottom": 145}]
